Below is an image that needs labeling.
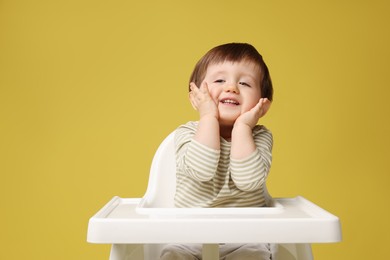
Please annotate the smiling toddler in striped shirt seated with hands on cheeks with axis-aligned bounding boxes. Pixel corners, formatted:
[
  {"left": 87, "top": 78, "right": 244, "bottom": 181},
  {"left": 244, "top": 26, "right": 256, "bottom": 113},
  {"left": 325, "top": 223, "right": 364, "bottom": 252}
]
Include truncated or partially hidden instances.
[{"left": 161, "top": 43, "right": 275, "bottom": 260}]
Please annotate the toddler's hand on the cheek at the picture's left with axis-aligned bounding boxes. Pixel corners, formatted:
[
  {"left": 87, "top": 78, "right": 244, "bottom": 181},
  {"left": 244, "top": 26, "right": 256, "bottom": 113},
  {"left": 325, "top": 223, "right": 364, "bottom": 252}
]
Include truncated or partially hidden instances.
[{"left": 190, "top": 82, "right": 219, "bottom": 119}]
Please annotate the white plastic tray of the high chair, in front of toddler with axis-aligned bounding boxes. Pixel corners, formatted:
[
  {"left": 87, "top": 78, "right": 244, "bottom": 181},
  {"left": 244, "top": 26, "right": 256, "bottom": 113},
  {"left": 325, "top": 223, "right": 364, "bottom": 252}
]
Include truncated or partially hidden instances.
[{"left": 87, "top": 196, "right": 341, "bottom": 244}]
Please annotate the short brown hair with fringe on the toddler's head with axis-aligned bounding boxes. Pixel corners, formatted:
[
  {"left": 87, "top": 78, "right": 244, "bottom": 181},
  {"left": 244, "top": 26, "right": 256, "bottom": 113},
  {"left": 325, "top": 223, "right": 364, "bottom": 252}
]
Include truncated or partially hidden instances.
[{"left": 190, "top": 43, "right": 273, "bottom": 101}]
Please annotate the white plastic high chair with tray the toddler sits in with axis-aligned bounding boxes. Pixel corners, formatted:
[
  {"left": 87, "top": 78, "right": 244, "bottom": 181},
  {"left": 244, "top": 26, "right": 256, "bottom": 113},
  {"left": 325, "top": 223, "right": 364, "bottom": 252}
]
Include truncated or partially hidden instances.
[{"left": 87, "top": 132, "right": 341, "bottom": 260}]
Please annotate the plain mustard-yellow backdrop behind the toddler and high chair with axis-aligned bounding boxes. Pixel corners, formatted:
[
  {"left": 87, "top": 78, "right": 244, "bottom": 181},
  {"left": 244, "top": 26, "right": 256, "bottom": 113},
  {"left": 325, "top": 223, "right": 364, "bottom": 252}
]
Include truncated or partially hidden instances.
[{"left": 0, "top": 0, "right": 390, "bottom": 260}]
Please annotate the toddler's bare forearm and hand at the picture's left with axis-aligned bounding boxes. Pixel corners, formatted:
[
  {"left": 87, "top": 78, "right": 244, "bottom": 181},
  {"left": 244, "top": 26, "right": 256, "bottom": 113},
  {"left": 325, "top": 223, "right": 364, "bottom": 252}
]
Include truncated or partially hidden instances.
[{"left": 190, "top": 82, "right": 220, "bottom": 150}]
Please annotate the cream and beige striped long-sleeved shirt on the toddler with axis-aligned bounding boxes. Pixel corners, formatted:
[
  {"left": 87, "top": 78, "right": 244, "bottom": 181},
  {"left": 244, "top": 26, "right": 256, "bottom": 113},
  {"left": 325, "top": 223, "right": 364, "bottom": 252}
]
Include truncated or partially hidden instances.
[{"left": 175, "top": 122, "right": 273, "bottom": 207}]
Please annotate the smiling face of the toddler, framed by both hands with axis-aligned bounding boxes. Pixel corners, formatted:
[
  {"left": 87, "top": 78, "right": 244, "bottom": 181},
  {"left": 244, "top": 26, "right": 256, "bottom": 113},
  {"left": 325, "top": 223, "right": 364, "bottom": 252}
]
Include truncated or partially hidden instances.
[{"left": 204, "top": 60, "right": 261, "bottom": 125}]
